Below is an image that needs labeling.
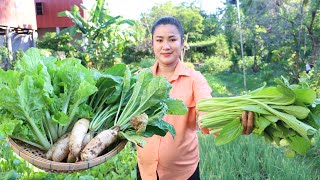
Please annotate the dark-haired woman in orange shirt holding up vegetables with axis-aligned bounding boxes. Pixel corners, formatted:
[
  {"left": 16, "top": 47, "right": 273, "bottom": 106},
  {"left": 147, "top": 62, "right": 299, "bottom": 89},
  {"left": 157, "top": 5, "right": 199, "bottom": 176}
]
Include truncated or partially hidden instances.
[{"left": 137, "top": 17, "right": 252, "bottom": 180}]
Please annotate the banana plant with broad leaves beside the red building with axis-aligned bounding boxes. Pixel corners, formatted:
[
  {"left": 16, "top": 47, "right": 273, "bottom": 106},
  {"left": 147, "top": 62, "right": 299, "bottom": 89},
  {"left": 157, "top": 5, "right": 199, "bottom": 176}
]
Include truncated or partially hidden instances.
[{"left": 58, "top": 0, "right": 135, "bottom": 69}]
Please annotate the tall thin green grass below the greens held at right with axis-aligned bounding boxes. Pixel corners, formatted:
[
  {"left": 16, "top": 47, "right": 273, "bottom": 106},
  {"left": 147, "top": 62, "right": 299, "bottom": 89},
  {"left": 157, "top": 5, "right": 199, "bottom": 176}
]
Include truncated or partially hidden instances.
[{"left": 199, "top": 134, "right": 320, "bottom": 180}]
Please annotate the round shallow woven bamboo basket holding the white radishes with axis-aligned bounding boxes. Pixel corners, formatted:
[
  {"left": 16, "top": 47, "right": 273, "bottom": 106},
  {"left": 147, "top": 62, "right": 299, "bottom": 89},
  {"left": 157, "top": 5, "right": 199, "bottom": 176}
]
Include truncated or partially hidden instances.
[{"left": 7, "top": 138, "right": 127, "bottom": 173}]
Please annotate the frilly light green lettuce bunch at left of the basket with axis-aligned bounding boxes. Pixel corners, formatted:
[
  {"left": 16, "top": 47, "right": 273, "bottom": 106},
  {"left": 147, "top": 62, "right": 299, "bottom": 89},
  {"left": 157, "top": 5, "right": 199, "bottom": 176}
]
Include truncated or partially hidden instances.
[{"left": 0, "top": 48, "right": 99, "bottom": 151}]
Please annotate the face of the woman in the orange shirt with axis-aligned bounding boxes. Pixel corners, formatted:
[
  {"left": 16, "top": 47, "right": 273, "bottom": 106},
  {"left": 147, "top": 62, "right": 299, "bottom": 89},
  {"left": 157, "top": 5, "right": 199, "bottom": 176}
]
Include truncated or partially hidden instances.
[{"left": 152, "top": 24, "right": 183, "bottom": 65}]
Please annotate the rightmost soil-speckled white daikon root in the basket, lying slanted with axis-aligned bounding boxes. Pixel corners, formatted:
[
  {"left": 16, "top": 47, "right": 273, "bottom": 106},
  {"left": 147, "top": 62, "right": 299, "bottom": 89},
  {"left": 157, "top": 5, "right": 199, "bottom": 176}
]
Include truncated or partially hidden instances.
[{"left": 81, "top": 128, "right": 119, "bottom": 161}]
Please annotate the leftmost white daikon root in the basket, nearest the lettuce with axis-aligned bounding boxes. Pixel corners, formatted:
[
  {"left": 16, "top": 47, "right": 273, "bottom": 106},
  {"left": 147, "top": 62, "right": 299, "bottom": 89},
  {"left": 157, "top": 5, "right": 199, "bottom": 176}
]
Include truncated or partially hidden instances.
[{"left": 52, "top": 133, "right": 70, "bottom": 162}]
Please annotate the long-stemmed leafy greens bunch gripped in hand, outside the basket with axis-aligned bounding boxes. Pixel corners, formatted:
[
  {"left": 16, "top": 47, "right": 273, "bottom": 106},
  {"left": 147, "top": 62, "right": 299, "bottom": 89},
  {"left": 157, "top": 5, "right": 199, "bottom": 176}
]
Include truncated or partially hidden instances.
[{"left": 197, "top": 74, "right": 320, "bottom": 157}]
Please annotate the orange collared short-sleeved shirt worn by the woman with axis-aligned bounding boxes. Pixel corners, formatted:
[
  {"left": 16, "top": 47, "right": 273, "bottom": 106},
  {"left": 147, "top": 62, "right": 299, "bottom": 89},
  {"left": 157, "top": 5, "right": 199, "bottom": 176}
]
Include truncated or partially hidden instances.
[{"left": 137, "top": 61, "right": 212, "bottom": 180}]
